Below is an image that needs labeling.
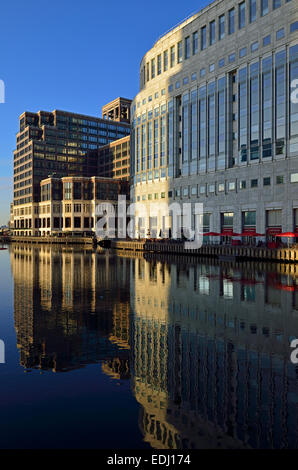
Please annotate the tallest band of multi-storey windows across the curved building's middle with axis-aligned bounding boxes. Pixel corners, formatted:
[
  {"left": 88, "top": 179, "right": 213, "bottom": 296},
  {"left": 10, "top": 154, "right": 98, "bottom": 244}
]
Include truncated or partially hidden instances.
[{"left": 132, "top": 45, "right": 298, "bottom": 176}]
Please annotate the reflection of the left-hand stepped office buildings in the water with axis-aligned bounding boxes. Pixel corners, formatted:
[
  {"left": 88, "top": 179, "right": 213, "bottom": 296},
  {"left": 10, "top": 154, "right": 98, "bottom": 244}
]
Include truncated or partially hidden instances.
[{"left": 11, "top": 245, "right": 130, "bottom": 375}]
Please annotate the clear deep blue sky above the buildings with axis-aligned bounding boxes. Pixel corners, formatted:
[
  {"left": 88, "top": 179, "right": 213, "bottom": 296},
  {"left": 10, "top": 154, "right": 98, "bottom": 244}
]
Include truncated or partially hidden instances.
[{"left": 0, "top": 0, "right": 211, "bottom": 226}]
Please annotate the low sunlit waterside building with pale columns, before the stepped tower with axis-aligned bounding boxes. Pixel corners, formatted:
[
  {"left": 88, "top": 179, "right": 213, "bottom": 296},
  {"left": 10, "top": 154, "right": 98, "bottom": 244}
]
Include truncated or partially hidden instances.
[{"left": 14, "top": 176, "right": 129, "bottom": 236}]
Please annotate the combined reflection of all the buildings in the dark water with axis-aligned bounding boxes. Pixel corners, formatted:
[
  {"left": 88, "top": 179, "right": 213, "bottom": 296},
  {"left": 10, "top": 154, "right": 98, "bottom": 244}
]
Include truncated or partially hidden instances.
[{"left": 11, "top": 246, "right": 298, "bottom": 449}]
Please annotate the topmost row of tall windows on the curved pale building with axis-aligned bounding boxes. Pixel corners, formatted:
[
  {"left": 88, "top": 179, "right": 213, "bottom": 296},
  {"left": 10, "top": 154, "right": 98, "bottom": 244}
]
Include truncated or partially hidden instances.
[{"left": 142, "top": 0, "right": 295, "bottom": 85}]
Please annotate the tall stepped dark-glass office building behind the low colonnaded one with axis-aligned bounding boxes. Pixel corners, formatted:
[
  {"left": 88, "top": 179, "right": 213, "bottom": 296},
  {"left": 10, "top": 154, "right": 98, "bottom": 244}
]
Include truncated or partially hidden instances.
[{"left": 13, "top": 98, "right": 130, "bottom": 235}]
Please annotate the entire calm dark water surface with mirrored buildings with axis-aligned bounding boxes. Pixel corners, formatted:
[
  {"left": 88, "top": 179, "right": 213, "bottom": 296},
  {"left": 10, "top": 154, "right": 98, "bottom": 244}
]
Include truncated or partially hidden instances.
[{"left": 0, "top": 245, "right": 298, "bottom": 449}]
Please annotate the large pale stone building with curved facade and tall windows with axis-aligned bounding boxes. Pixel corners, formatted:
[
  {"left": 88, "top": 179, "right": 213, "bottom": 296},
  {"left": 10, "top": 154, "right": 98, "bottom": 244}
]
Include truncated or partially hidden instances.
[{"left": 131, "top": 0, "right": 298, "bottom": 236}]
